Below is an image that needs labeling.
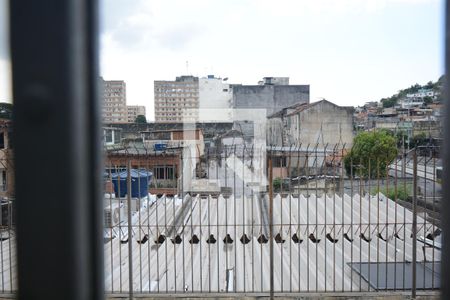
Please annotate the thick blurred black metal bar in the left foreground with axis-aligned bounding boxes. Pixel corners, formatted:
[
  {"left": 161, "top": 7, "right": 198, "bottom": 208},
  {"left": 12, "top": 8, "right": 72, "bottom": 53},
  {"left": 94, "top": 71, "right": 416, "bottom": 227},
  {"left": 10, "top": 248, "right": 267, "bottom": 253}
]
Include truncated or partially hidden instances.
[{"left": 10, "top": 0, "right": 104, "bottom": 299}]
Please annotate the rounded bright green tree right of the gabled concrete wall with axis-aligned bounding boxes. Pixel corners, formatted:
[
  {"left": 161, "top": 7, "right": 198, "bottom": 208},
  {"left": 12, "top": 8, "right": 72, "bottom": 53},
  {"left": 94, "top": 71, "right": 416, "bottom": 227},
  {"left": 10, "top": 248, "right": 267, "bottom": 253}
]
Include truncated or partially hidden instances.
[{"left": 344, "top": 130, "right": 397, "bottom": 178}]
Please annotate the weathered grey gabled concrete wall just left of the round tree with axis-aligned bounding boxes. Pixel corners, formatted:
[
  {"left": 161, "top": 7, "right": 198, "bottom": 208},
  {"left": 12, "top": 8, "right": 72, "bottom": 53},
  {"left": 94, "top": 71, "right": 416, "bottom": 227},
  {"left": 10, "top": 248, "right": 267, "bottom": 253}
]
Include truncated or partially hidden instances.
[{"left": 286, "top": 101, "right": 354, "bottom": 148}]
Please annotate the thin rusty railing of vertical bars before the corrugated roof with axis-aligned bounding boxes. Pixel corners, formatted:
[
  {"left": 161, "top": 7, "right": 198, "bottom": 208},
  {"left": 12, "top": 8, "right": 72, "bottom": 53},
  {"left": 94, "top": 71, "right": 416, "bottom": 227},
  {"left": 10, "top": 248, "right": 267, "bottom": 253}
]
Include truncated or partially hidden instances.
[{"left": 97, "top": 145, "right": 442, "bottom": 296}]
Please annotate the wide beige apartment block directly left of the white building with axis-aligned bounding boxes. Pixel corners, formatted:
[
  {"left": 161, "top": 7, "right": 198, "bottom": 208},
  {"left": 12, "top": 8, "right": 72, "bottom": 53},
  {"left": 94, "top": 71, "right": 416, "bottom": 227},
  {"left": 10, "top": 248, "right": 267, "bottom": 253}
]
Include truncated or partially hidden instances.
[{"left": 154, "top": 76, "right": 199, "bottom": 123}]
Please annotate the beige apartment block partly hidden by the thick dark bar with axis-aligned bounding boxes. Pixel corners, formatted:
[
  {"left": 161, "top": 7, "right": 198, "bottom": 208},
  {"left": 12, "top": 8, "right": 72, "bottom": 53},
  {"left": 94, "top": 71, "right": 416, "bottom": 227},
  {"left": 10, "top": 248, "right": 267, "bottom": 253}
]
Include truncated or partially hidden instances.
[{"left": 102, "top": 79, "right": 128, "bottom": 123}]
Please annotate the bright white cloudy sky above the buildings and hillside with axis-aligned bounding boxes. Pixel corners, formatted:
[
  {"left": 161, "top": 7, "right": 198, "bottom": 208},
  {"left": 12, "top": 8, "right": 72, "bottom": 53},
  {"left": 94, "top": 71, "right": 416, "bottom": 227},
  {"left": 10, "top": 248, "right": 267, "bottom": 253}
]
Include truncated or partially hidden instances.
[{"left": 0, "top": 0, "right": 445, "bottom": 120}]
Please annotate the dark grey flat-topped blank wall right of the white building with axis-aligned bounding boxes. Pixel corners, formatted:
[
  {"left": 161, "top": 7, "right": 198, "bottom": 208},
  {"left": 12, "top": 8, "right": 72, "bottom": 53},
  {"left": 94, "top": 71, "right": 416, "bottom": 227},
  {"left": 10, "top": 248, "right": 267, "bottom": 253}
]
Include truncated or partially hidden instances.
[{"left": 232, "top": 85, "right": 309, "bottom": 115}]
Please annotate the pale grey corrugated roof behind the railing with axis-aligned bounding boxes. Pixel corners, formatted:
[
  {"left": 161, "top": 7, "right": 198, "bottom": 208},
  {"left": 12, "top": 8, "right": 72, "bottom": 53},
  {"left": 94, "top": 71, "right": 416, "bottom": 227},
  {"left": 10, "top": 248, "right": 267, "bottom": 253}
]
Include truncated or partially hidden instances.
[{"left": 101, "top": 194, "right": 440, "bottom": 292}]
